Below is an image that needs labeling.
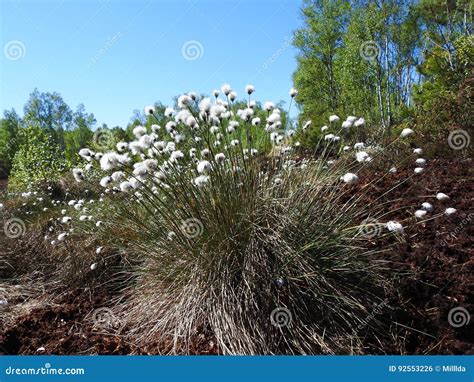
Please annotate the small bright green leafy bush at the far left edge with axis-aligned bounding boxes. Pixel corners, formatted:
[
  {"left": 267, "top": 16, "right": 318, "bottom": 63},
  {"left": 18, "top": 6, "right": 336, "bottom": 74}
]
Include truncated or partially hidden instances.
[{"left": 8, "top": 126, "right": 67, "bottom": 190}]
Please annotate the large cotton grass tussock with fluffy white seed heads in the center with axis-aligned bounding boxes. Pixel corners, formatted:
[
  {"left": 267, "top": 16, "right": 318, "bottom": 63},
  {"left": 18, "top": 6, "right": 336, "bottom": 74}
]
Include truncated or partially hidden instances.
[{"left": 61, "top": 85, "right": 454, "bottom": 354}]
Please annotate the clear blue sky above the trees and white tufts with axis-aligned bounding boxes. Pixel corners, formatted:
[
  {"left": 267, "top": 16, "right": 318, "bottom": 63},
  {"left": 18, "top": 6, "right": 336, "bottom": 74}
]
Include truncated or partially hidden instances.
[{"left": 0, "top": 0, "right": 301, "bottom": 126}]
